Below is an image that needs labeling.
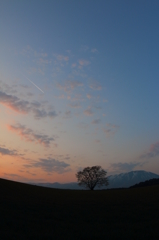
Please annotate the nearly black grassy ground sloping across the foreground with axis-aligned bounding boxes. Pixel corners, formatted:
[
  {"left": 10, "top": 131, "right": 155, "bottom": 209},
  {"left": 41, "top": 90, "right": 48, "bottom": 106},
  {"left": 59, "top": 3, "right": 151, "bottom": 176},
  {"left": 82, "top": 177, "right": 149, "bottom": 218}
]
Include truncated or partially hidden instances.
[{"left": 0, "top": 179, "right": 159, "bottom": 240}]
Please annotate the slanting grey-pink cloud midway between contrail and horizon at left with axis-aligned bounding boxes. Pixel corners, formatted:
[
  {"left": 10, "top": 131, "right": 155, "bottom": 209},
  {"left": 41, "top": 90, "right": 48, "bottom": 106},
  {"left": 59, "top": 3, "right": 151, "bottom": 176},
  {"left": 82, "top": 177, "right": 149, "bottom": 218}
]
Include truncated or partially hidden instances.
[{"left": 8, "top": 124, "right": 55, "bottom": 147}]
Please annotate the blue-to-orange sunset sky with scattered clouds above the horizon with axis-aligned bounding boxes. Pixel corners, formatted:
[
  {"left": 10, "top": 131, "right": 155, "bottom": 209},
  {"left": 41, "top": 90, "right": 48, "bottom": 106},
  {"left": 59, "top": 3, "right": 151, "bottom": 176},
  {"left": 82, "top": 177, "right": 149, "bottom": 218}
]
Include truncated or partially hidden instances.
[{"left": 0, "top": 0, "right": 159, "bottom": 183}]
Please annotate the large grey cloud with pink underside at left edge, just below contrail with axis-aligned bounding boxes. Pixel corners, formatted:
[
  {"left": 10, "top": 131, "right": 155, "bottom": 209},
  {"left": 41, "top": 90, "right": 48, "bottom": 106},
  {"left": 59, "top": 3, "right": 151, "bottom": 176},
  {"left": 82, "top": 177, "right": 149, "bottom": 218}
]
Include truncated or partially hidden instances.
[{"left": 0, "top": 91, "right": 57, "bottom": 119}]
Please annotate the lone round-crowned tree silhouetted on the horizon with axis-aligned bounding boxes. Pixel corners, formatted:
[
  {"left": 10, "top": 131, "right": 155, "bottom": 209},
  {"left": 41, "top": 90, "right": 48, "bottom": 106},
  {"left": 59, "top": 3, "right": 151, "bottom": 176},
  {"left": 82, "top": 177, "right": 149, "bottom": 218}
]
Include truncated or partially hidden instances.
[{"left": 76, "top": 166, "right": 109, "bottom": 190}]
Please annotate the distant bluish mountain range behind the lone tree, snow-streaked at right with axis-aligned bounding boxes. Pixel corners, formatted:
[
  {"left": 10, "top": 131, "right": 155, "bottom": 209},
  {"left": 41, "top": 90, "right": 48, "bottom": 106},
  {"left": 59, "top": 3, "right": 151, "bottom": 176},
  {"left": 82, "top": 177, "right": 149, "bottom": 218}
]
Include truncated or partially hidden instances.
[{"left": 31, "top": 171, "right": 159, "bottom": 190}]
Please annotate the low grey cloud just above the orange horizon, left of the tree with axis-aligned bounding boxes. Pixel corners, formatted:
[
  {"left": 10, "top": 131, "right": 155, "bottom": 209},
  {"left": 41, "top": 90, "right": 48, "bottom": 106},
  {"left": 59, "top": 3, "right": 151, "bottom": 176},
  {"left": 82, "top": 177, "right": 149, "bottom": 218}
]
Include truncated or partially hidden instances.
[{"left": 24, "top": 158, "right": 70, "bottom": 174}]
